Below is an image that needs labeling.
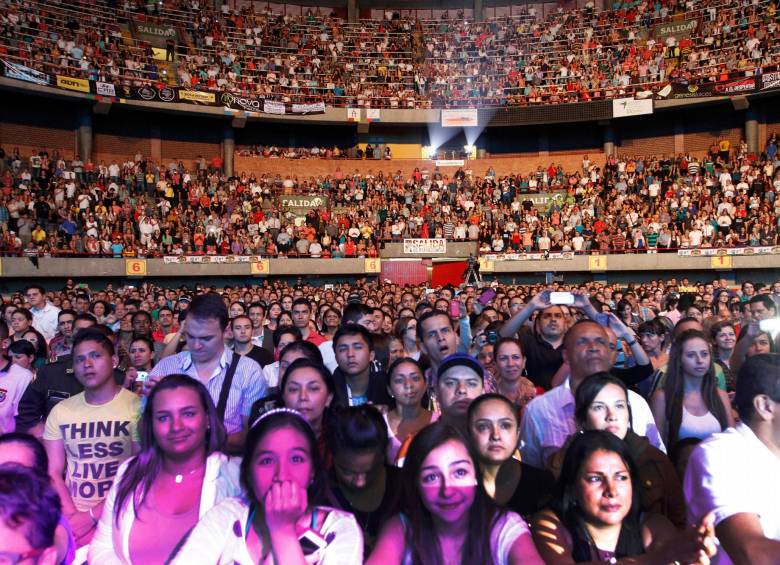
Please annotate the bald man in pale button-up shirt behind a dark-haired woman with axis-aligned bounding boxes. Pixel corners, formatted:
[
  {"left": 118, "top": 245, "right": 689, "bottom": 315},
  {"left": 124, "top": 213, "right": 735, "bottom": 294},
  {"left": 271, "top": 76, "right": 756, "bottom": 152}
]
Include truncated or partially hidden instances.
[{"left": 520, "top": 320, "right": 664, "bottom": 469}]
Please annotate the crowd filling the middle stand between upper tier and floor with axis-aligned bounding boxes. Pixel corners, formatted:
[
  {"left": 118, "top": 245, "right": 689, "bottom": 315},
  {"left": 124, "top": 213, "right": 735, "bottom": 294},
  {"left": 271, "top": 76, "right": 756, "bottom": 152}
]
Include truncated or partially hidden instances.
[{"left": 0, "top": 133, "right": 780, "bottom": 258}]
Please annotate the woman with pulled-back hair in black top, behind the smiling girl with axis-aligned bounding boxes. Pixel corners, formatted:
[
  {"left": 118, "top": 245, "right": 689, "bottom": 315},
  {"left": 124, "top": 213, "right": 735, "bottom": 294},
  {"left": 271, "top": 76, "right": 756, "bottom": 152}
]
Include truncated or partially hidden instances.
[{"left": 468, "top": 394, "right": 554, "bottom": 516}]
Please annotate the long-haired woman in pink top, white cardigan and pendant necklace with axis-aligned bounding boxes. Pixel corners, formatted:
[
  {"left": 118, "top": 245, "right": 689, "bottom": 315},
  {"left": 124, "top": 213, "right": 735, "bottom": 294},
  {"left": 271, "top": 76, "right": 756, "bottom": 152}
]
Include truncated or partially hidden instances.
[{"left": 89, "top": 374, "right": 241, "bottom": 565}]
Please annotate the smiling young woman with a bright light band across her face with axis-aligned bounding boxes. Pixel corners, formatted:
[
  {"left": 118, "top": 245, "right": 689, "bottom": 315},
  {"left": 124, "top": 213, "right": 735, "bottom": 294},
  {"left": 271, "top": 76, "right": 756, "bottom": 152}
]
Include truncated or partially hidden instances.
[{"left": 367, "top": 422, "right": 544, "bottom": 565}]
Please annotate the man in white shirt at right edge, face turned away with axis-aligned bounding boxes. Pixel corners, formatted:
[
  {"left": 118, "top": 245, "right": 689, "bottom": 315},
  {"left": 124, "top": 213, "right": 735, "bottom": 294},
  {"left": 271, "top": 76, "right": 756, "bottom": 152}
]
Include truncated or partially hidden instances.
[{"left": 683, "top": 353, "right": 780, "bottom": 565}]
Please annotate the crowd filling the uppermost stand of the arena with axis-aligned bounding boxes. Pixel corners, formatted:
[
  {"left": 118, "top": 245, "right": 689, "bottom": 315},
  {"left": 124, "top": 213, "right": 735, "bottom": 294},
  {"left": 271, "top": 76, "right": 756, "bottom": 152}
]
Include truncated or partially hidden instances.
[{"left": 0, "top": 0, "right": 780, "bottom": 108}]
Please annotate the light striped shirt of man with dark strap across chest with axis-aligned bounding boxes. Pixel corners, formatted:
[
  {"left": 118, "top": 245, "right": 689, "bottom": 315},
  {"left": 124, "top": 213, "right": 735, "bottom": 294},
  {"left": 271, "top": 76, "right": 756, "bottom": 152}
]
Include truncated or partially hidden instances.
[{"left": 149, "top": 347, "right": 268, "bottom": 434}]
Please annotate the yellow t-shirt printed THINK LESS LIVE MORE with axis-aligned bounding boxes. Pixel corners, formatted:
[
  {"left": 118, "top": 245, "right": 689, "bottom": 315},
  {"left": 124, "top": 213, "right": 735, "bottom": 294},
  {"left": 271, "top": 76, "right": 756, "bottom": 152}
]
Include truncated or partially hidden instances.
[{"left": 43, "top": 388, "right": 141, "bottom": 512}]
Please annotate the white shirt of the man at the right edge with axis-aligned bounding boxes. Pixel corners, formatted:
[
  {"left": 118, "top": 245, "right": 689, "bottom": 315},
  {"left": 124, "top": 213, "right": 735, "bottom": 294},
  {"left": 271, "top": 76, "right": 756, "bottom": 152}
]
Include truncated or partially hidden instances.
[{"left": 683, "top": 423, "right": 780, "bottom": 565}]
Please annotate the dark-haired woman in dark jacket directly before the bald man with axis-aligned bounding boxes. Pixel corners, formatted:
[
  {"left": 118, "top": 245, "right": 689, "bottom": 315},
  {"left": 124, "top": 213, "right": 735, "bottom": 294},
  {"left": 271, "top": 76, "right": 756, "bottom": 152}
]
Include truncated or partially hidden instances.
[{"left": 564, "top": 373, "right": 687, "bottom": 529}]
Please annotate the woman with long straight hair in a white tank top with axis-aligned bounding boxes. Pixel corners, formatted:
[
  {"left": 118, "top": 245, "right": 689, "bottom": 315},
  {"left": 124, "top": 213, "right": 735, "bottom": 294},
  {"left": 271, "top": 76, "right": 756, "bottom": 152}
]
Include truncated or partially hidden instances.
[{"left": 650, "top": 330, "right": 734, "bottom": 449}]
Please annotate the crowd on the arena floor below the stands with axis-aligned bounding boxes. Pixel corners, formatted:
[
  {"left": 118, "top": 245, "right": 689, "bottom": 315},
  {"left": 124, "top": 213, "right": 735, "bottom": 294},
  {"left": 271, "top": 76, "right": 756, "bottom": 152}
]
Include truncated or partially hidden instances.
[{"left": 0, "top": 272, "right": 780, "bottom": 565}]
